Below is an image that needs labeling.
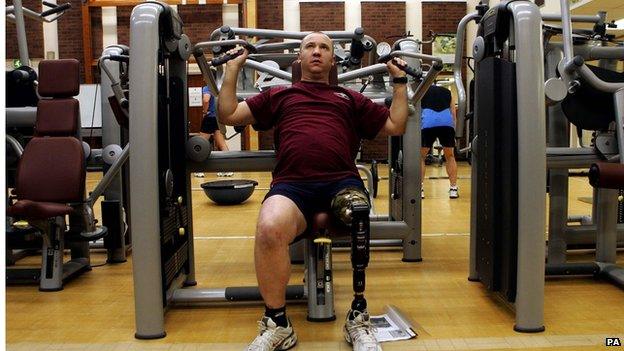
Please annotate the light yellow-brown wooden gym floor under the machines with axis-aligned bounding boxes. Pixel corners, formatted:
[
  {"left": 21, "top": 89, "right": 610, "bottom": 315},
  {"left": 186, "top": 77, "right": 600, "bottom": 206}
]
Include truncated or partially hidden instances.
[{"left": 6, "top": 165, "right": 624, "bottom": 351}]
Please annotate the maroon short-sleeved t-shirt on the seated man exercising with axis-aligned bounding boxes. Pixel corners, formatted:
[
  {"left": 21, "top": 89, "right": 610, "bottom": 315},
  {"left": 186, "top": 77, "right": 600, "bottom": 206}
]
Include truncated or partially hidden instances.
[{"left": 246, "top": 82, "right": 390, "bottom": 184}]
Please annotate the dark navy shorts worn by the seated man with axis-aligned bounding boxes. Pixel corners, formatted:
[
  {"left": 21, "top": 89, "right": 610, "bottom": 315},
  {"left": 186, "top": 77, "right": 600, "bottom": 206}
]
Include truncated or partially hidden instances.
[{"left": 262, "top": 177, "right": 368, "bottom": 232}]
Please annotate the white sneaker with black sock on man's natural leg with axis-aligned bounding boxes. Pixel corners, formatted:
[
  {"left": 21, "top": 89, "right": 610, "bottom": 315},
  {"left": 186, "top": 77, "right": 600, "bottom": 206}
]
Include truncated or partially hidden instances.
[{"left": 245, "top": 316, "right": 297, "bottom": 351}]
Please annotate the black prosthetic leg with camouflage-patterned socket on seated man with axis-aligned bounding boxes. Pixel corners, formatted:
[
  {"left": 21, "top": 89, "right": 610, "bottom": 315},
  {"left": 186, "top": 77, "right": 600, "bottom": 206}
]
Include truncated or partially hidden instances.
[{"left": 331, "top": 187, "right": 370, "bottom": 312}]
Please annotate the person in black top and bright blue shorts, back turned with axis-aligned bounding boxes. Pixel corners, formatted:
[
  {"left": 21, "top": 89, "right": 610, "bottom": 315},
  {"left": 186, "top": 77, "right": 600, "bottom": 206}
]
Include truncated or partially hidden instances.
[{"left": 420, "top": 85, "right": 459, "bottom": 199}]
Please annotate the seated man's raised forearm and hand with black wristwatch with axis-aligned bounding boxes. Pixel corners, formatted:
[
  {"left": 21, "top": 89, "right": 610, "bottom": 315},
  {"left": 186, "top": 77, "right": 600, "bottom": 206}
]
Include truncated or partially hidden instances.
[{"left": 380, "top": 59, "right": 409, "bottom": 136}]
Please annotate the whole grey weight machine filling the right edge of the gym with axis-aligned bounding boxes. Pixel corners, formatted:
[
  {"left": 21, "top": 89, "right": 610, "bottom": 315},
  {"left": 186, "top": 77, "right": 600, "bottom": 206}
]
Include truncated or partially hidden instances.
[{"left": 455, "top": 0, "right": 624, "bottom": 332}]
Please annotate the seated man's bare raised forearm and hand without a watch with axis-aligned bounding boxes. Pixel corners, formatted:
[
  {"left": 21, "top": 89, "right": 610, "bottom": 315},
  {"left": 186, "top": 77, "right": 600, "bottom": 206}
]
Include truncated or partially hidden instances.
[{"left": 218, "top": 49, "right": 256, "bottom": 126}]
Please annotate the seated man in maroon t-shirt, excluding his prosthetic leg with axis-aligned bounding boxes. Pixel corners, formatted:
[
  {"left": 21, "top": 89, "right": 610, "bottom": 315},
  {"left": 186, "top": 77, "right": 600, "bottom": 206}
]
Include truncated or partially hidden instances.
[{"left": 218, "top": 32, "right": 408, "bottom": 351}]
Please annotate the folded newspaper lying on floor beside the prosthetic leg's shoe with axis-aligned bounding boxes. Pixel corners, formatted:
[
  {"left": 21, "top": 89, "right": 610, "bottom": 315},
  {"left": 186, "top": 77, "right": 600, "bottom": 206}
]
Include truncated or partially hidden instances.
[{"left": 370, "top": 305, "right": 418, "bottom": 342}]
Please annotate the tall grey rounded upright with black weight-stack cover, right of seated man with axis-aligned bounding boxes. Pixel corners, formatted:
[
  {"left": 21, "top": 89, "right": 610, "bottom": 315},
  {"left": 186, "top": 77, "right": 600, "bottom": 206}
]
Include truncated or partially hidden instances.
[{"left": 469, "top": 1, "right": 546, "bottom": 332}]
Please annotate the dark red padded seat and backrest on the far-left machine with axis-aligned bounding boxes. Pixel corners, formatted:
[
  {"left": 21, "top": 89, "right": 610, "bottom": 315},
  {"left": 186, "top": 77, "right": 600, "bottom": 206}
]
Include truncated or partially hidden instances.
[{"left": 7, "top": 59, "right": 86, "bottom": 219}]
